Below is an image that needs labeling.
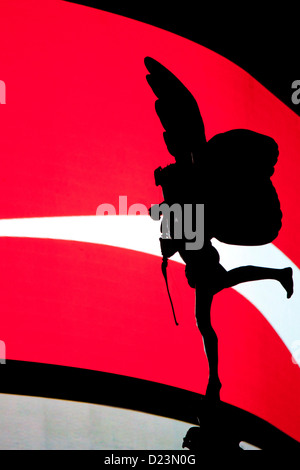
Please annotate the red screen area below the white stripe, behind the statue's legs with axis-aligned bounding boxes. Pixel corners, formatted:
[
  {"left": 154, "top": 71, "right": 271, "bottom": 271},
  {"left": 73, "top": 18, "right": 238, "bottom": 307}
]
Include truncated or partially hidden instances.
[{"left": 0, "top": 238, "right": 300, "bottom": 439}]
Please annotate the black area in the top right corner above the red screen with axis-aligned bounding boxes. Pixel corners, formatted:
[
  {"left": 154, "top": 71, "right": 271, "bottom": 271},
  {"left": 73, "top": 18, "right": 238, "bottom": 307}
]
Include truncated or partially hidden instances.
[{"left": 65, "top": 0, "right": 300, "bottom": 115}]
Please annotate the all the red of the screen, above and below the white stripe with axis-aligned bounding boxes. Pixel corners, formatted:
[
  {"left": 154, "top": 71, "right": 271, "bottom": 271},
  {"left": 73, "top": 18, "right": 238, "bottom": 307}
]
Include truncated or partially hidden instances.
[{"left": 0, "top": 0, "right": 300, "bottom": 439}]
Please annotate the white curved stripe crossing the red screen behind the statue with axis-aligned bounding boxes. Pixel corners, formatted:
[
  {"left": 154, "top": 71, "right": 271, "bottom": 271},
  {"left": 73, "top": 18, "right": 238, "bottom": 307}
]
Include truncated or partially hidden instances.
[{"left": 0, "top": 215, "right": 300, "bottom": 365}]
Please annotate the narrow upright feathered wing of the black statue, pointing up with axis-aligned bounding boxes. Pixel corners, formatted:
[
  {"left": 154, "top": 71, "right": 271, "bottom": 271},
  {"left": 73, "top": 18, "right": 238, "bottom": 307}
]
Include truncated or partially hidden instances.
[{"left": 145, "top": 57, "right": 206, "bottom": 161}]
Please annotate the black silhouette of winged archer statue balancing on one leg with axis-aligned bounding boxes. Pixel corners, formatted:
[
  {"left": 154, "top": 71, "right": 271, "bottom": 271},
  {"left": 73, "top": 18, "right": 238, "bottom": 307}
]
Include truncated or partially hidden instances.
[{"left": 145, "top": 57, "right": 293, "bottom": 401}]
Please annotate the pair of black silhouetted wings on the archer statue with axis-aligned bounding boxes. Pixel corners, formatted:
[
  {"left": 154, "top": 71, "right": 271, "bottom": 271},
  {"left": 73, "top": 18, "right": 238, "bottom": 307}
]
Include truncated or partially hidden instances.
[{"left": 145, "top": 57, "right": 282, "bottom": 245}]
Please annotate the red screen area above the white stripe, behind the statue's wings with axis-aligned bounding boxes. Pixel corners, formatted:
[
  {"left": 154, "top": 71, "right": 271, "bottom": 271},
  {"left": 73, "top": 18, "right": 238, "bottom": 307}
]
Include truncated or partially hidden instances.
[{"left": 0, "top": 0, "right": 300, "bottom": 265}]
